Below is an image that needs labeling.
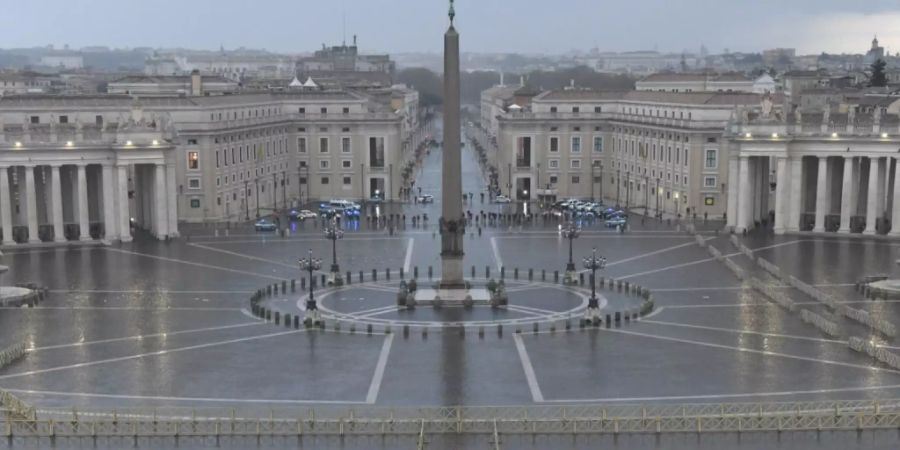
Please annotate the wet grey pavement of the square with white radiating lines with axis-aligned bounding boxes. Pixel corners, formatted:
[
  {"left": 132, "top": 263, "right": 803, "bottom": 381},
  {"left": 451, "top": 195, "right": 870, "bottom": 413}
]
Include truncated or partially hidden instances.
[{"left": 0, "top": 125, "right": 900, "bottom": 449}]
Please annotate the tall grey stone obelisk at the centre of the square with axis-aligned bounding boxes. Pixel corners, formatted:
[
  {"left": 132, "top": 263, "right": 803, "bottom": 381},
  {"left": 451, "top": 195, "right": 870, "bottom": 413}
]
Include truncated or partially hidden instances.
[{"left": 440, "top": 0, "right": 466, "bottom": 289}]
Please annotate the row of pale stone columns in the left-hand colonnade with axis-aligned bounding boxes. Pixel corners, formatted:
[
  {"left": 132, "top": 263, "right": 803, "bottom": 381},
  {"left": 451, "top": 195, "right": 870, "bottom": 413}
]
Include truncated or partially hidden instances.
[{"left": 0, "top": 162, "right": 177, "bottom": 245}]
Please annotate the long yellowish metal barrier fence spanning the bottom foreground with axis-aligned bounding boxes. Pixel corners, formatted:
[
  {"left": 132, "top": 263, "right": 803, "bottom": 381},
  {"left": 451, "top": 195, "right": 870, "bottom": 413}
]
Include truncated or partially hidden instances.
[{"left": 12, "top": 400, "right": 900, "bottom": 437}]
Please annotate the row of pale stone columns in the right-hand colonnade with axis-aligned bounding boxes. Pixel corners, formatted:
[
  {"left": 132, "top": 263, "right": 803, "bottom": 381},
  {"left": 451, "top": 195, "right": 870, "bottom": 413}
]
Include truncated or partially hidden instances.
[{"left": 728, "top": 152, "right": 900, "bottom": 236}]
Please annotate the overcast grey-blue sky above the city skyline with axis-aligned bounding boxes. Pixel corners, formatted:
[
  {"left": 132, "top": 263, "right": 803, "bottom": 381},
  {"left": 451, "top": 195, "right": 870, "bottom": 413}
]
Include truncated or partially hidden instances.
[{"left": 0, "top": 0, "right": 900, "bottom": 53}]
